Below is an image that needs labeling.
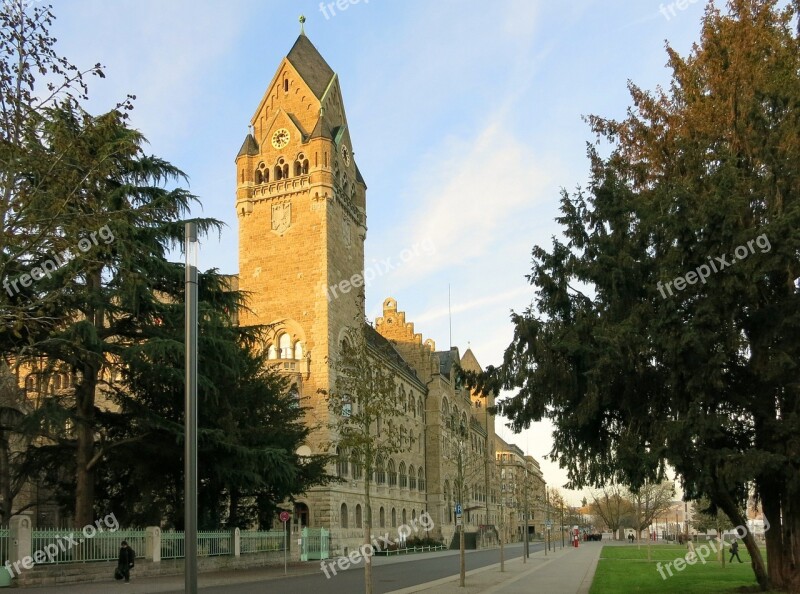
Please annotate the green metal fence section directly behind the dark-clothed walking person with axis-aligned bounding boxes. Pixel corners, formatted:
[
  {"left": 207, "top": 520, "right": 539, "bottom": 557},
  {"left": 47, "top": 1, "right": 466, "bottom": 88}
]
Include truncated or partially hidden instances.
[{"left": 29, "top": 528, "right": 146, "bottom": 565}]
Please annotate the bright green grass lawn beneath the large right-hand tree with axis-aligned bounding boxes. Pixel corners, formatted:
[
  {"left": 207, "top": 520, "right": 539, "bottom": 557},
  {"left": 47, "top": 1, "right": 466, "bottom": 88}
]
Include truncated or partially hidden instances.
[{"left": 590, "top": 542, "right": 765, "bottom": 594}]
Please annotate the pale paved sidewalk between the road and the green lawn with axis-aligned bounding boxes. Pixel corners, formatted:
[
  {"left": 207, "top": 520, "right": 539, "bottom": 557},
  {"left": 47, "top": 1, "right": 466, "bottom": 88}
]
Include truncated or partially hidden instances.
[{"left": 389, "top": 542, "right": 612, "bottom": 594}]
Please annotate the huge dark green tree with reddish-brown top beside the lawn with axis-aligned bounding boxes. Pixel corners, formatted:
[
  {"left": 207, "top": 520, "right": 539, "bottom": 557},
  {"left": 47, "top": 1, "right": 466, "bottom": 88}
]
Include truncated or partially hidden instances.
[{"left": 472, "top": 0, "right": 800, "bottom": 590}]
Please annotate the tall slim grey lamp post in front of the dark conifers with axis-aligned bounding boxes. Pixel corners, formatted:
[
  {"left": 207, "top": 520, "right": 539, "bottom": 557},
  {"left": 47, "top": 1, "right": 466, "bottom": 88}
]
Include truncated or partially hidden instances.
[{"left": 184, "top": 223, "right": 198, "bottom": 594}]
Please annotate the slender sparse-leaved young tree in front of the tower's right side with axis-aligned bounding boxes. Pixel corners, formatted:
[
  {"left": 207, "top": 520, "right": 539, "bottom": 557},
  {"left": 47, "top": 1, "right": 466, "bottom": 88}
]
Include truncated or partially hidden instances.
[{"left": 322, "top": 320, "right": 413, "bottom": 594}]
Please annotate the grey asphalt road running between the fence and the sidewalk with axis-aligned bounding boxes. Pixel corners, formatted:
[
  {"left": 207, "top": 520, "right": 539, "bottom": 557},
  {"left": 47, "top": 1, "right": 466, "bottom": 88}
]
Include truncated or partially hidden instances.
[{"left": 169, "top": 543, "right": 543, "bottom": 594}]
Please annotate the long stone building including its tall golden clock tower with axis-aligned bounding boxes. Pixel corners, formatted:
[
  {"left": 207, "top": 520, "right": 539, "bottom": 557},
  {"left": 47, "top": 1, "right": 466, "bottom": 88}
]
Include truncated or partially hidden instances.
[{"left": 231, "top": 34, "right": 541, "bottom": 552}]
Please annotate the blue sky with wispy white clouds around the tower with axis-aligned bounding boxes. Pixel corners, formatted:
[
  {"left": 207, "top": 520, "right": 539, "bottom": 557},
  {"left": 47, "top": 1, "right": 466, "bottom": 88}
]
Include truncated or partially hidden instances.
[{"left": 47, "top": 0, "right": 704, "bottom": 501}]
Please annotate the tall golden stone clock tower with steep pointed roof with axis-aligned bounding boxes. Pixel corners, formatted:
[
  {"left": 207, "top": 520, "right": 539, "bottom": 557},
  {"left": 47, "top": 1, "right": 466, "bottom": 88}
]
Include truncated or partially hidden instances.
[{"left": 236, "top": 33, "right": 367, "bottom": 526}]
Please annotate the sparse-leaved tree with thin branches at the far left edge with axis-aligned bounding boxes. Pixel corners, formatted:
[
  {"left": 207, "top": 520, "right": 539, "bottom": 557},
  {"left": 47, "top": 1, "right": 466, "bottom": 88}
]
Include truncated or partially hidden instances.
[{"left": 0, "top": 0, "right": 106, "bottom": 352}]
